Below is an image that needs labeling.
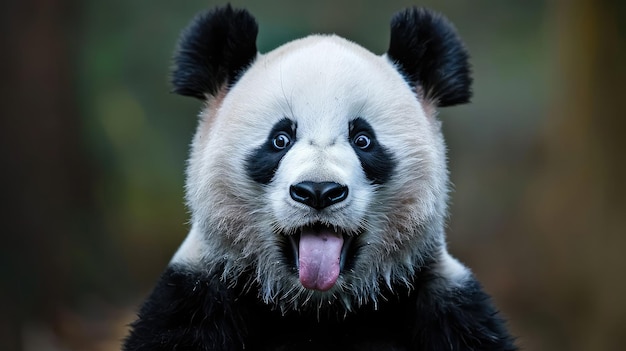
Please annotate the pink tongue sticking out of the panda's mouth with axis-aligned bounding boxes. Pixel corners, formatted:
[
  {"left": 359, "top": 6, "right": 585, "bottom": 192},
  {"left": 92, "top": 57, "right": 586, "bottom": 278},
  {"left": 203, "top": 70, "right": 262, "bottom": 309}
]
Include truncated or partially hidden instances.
[{"left": 299, "top": 228, "right": 343, "bottom": 291}]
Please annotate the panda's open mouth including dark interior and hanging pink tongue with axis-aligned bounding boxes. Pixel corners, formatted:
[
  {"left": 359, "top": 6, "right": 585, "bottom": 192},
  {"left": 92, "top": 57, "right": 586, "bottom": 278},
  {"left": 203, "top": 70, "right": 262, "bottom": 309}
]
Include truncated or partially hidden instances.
[{"left": 289, "top": 223, "right": 354, "bottom": 291}]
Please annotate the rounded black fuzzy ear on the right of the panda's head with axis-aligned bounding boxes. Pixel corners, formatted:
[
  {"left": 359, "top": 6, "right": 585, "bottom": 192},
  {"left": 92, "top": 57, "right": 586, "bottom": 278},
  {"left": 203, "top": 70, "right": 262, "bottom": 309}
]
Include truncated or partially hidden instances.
[{"left": 387, "top": 8, "right": 472, "bottom": 106}]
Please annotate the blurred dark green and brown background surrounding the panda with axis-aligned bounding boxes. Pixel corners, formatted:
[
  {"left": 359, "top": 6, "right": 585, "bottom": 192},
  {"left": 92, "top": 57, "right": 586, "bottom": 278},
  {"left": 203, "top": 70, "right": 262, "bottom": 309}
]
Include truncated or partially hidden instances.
[{"left": 0, "top": 0, "right": 626, "bottom": 351}]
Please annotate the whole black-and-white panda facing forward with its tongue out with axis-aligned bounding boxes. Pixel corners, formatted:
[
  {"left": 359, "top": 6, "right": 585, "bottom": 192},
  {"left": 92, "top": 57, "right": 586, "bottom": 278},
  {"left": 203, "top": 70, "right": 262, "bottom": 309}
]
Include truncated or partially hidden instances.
[{"left": 123, "top": 5, "right": 516, "bottom": 351}]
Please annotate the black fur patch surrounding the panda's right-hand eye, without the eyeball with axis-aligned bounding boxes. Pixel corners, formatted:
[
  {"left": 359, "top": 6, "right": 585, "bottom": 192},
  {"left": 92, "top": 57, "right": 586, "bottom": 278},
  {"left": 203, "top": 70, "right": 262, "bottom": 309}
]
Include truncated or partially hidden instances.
[{"left": 349, "top": 118, "right": 396, "bottom": 184}]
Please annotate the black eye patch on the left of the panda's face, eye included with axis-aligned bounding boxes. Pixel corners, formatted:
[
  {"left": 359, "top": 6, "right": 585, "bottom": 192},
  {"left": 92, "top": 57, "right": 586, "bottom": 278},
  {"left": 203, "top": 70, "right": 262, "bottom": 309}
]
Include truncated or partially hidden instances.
[{"left": 246, "top": 118, "right": 296, "bottom": 184}]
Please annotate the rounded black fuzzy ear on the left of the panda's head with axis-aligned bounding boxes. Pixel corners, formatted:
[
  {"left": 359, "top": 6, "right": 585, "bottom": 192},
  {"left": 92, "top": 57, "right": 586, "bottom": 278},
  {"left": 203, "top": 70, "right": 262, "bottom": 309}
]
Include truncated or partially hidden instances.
[{"left": 172, "top": 5, "right": 258, "bottom": 100}]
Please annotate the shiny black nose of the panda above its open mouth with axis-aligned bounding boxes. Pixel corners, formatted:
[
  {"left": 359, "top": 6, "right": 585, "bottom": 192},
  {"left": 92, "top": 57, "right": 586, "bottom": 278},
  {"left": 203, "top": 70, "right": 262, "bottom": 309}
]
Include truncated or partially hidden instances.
[{"left": 289, "top": 182, "right": 348, "bottom": 210}]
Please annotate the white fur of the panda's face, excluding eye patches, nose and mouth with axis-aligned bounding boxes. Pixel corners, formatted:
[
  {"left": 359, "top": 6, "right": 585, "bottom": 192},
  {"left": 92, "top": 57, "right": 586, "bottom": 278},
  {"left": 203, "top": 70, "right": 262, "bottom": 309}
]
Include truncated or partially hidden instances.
[{"left": 172, "top": 36, "right": 456, "bottom": 309}]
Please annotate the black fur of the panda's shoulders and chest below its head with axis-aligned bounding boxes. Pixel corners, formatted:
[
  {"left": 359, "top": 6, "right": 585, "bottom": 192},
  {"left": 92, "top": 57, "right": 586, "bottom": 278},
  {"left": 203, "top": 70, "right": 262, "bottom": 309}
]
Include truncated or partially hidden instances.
[{"left": 123, "top": 266, "right": 516, "bottom": 351}]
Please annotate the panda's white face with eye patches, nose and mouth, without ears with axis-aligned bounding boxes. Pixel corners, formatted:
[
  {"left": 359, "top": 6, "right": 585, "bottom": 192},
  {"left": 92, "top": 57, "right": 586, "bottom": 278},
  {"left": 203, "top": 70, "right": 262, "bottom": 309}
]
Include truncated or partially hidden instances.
[{"left": 187, "top": 36, "right": 447, "bottom": 306}]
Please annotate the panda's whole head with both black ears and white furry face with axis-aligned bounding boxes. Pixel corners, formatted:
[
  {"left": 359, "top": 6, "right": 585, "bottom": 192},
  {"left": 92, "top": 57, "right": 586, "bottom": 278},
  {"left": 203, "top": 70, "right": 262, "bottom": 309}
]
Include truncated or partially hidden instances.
[{"left": 168, "top": 6, "right": 471, "bottom": 309}]
